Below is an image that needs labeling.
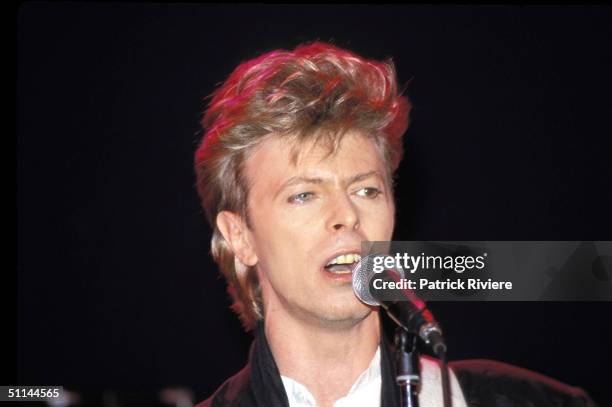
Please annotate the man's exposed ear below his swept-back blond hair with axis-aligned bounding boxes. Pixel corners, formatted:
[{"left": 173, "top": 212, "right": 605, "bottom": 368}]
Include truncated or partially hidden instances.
[{"left": 216, "top": 211, "right": 258, "bottom": 266}]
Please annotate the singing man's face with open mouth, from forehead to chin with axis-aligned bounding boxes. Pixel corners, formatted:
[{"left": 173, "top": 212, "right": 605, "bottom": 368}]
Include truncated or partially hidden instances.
[{"left": 245, "top": 132, "right": 395, "bottom": 324}]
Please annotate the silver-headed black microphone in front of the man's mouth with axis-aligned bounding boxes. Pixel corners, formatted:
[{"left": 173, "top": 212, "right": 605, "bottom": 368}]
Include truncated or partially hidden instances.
[{"left": 353, "top": 254, "right": 446, "bottom": 359}]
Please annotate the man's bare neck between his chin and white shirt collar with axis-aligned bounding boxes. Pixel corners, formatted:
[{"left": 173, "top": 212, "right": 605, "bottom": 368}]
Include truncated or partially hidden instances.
[{"left": 265, "top": 312, "right": 380, "bottom": 407}]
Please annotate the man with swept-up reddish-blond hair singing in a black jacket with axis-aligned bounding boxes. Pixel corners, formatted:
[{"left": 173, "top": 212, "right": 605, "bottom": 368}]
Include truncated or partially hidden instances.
[{"left": 195, "top": 43, "right": 590, "bottom": 407}]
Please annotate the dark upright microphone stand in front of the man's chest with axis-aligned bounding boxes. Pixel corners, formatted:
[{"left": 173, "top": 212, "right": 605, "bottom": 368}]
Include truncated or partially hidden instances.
[{"left": 395, "top": 326, "right": 421, "bottom": 407}]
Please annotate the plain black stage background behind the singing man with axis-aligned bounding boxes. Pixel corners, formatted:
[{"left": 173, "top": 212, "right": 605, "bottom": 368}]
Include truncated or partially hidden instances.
[{"left": 17, "top": 3, "right": 612, "bottom": 406}]
